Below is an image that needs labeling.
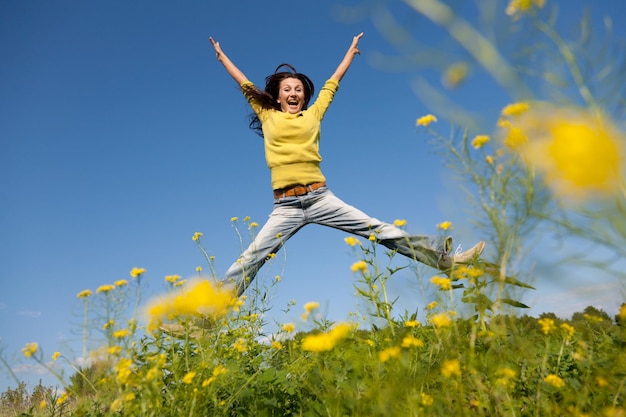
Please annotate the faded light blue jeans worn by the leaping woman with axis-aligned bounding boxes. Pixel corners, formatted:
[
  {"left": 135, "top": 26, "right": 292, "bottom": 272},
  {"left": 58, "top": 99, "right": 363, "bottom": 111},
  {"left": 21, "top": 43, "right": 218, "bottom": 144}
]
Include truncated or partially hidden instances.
[{"left": 222, "top": 187, "right": 452, "bottom": 295}]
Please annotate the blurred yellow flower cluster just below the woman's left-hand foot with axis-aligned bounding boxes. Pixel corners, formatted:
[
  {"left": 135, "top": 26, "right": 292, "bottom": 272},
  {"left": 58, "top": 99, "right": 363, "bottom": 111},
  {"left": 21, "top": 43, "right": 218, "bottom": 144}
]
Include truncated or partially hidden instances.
[{"left": 146, "top": 279, "right": 237, "bottom": 321}]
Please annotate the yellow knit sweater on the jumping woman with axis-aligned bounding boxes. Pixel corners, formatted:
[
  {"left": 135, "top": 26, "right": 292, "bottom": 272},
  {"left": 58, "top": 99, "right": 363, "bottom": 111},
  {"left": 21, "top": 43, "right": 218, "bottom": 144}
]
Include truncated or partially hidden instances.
[{"left": 241, "top": 79, "right": 339, "bottom": 190}]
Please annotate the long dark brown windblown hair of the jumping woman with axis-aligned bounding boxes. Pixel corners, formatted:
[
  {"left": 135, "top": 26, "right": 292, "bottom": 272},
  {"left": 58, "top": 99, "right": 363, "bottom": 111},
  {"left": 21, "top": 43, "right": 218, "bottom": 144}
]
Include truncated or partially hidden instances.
[{"left": 245, "top": 64, "right": 315, "bottom": 137}]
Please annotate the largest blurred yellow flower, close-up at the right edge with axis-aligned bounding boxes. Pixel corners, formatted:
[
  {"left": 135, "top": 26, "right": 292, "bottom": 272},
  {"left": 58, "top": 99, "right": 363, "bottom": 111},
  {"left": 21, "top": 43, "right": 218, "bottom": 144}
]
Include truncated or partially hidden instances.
[{"left": 500, "top": 104, "right": 626, "bottom": 200}]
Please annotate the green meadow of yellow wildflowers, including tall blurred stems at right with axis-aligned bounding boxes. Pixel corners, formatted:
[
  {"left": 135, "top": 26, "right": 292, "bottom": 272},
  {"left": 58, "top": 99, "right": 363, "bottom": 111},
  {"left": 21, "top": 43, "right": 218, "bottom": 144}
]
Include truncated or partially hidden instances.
[{"left": 0, "top": 0, "right": 626, "bottom": 417}]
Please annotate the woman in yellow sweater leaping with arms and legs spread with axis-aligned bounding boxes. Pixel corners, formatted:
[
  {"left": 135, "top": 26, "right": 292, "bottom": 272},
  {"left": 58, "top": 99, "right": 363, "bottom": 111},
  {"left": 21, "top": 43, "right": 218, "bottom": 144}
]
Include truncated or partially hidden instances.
[{"left": 209, "top": 33, "right": 485, "bottom": 295}]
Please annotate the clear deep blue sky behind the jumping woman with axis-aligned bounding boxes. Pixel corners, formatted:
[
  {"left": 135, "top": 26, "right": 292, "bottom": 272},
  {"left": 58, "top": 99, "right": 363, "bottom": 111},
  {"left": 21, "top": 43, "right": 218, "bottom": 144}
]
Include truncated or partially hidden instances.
[{"left": 0, "top": 0, "right": 625, "bottom": 390}]
